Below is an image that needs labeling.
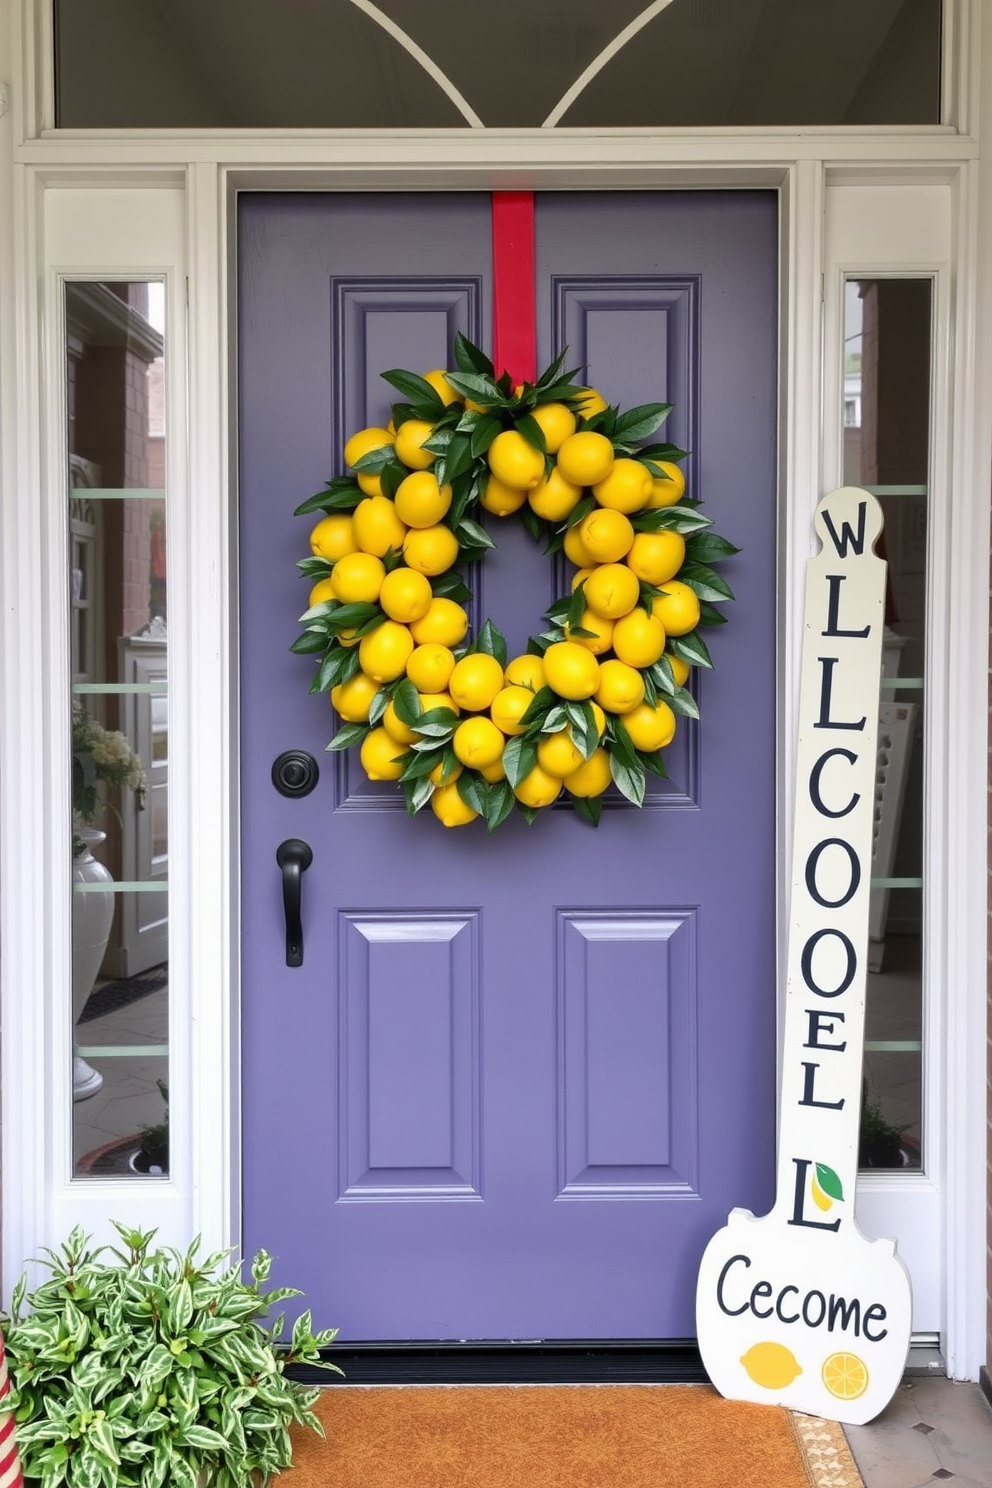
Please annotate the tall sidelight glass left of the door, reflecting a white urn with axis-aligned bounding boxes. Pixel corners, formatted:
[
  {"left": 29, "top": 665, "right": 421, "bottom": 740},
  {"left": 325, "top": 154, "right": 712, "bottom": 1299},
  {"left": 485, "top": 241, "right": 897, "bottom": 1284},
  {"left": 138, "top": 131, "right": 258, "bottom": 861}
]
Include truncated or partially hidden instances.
[{"left": 65, "top": 281, "right": 168, "bottom": 1178}]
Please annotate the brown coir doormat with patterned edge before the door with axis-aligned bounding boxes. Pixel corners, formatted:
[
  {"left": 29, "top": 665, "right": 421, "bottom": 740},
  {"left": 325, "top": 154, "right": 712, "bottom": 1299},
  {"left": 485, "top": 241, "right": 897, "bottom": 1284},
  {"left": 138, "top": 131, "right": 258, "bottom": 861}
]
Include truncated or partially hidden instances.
[{"left": 278, "top": 1385, "right": 864, "bottom": 1488}]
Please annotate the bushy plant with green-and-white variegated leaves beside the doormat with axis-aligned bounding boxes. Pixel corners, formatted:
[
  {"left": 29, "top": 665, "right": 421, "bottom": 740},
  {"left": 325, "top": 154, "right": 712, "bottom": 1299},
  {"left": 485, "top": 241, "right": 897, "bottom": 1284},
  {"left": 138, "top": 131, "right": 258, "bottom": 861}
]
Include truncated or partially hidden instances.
[{"left": 1, "top": 1225, "right": 341, "bottom": 1488}]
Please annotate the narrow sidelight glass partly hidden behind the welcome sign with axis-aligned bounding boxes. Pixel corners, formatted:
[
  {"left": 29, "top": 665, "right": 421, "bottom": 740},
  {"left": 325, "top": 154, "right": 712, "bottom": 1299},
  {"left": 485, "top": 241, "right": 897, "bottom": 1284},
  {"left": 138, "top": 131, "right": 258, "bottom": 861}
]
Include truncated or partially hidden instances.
[{"left": 843, "top": 278, "right": 933, "bottom": 1168}]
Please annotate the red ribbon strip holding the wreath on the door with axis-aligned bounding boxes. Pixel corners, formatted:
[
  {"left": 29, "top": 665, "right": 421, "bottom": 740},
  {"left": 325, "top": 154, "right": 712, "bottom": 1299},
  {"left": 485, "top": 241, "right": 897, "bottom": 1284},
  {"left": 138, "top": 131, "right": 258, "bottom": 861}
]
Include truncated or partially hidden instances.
[{"left": 492, "top": 190, "right": 537, "bottom": 384}]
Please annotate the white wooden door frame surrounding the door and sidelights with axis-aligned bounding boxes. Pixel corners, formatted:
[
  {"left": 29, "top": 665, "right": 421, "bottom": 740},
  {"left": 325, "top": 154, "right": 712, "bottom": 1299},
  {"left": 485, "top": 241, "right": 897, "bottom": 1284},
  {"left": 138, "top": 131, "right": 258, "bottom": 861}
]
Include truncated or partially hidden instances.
[{"left": 0, "top": 0, "right": 992, "bottom": 1378}]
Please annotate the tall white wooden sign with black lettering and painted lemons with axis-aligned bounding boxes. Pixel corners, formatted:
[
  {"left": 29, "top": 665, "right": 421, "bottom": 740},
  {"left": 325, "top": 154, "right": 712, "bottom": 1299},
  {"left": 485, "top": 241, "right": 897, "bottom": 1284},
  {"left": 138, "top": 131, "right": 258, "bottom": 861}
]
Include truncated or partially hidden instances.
[{"left": 696, "top": 487, "right": 912, "bottom": 1424}]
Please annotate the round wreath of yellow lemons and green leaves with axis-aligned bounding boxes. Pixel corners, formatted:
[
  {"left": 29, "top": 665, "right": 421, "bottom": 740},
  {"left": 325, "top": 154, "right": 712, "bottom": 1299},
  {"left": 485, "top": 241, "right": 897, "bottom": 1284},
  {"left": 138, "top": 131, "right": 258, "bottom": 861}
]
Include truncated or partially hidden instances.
[{"left": 292, "top": 335, "right": 738, "bottom": 832}]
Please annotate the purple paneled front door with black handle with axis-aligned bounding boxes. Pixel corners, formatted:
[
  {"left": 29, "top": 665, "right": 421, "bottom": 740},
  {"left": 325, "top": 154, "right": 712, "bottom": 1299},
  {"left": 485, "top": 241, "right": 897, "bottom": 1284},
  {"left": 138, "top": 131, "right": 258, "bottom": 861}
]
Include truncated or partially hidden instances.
[{"left": 239, "top": 192, "right": 776, "bottom": 1341}]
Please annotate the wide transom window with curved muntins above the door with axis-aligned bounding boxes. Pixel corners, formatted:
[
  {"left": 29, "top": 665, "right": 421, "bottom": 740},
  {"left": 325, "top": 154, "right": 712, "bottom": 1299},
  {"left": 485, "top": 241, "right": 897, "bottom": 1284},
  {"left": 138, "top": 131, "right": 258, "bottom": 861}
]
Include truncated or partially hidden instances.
[{"left": 55, "top": 0, "right": 940, "bottom": 129}]
